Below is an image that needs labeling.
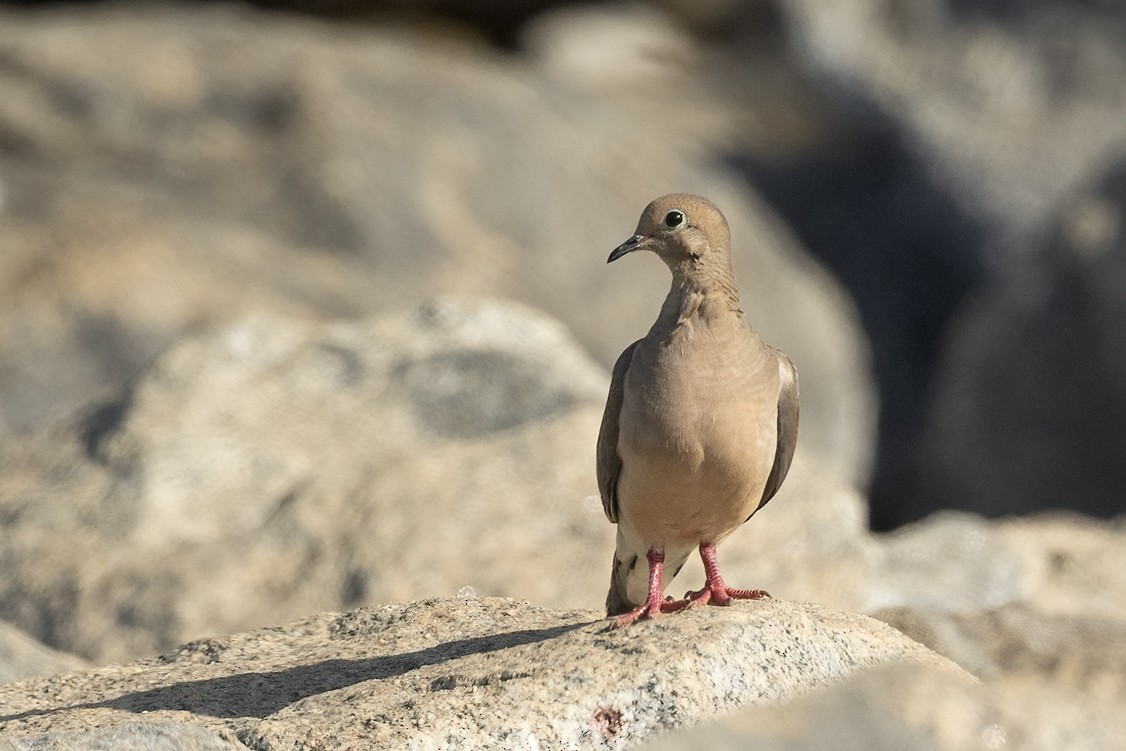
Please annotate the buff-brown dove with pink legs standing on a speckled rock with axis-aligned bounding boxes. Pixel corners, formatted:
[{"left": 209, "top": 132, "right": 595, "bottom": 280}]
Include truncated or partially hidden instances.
[{"left": 597, "top": 194, "right": 798, "bottom": 627}]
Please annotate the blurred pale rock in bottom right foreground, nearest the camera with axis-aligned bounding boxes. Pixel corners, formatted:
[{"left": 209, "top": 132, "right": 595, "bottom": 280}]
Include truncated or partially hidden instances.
[{"left": 642, "top": 665, "right": 1126, "bottom": 751}]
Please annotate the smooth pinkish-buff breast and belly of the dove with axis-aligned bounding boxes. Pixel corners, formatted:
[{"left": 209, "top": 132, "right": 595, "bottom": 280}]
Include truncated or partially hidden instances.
[{"left": 618, "top": 331, "right": 778, "bottom": 543}]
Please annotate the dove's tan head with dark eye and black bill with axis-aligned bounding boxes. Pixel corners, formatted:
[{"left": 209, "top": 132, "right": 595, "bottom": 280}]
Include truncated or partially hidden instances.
[{"left": 607, "top": 193, "right": 731, "bottom": 270}]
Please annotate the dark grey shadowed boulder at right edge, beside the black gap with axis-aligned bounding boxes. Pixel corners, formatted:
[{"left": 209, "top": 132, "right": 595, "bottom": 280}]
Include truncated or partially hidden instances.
[{"left": 910, "top": 157, "right": 1126, "bottom": 517}]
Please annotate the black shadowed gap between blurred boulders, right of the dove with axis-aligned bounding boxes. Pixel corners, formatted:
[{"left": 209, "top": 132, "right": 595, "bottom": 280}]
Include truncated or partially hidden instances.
[{"left": 731, "top": 111, "right": 988, "bottom": 529}]
